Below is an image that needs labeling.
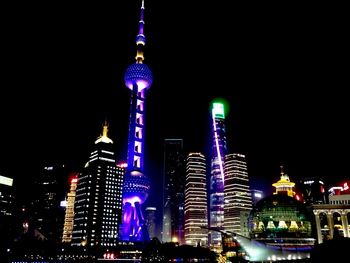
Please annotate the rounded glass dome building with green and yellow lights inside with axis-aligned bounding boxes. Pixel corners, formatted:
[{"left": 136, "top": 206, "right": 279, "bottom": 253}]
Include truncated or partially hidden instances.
[{"left": 249, "top": 194, "right": 315, "bottom": 250}]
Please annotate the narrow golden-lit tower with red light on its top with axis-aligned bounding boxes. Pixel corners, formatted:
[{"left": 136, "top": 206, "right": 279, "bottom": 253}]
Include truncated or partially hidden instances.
[{"left": 62, "top": 173, "right": 79, "bottom": 243}]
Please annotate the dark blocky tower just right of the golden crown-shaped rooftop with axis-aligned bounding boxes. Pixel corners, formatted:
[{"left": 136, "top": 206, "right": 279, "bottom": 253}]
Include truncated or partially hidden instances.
[{"left": 299, "top": 177, "right": 327, "bottom": 205}]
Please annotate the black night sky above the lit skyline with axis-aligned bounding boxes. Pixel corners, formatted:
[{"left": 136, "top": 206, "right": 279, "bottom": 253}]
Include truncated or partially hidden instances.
[{"left": 0, "top": 0, "right": 350, "bottom": 203}]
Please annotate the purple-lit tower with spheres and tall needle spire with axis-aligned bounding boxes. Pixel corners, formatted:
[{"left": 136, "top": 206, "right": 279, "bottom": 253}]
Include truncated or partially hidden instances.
[{"left": 121, "top": 1, "right": 153, "bottom": 241}]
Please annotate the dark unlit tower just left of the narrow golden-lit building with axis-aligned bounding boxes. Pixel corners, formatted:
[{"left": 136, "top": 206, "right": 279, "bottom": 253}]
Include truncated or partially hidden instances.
[{"left": 29, "top": 162, "right": 68, "bottom": 242}]
